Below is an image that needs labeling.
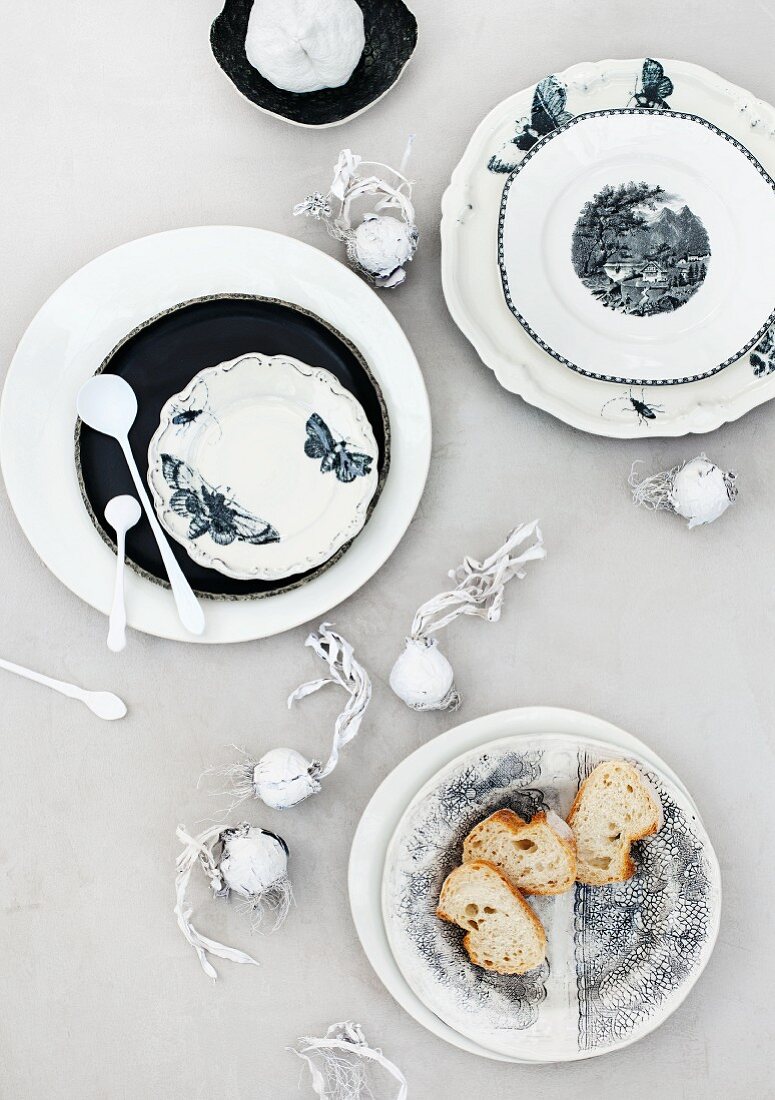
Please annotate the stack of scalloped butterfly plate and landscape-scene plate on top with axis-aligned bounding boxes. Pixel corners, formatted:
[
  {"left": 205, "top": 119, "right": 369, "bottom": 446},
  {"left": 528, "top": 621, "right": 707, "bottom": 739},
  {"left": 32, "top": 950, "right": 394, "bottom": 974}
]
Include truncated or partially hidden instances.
[{"left": 442, "top": 58, "right": 775, "bottom": 437}]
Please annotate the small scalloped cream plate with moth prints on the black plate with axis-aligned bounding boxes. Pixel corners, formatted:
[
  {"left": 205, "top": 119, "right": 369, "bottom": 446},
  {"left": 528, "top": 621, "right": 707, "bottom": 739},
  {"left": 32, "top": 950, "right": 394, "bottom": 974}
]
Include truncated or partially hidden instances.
[{"left": 148, "top": 353, "right": 378, "bottom": 580}]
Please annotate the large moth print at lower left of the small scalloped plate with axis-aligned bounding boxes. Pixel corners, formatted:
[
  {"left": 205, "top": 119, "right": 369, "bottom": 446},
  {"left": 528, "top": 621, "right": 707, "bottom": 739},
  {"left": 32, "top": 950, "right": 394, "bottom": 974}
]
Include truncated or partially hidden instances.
[{"left": 162, "top": 454, "right": 280, "bottom": 547}]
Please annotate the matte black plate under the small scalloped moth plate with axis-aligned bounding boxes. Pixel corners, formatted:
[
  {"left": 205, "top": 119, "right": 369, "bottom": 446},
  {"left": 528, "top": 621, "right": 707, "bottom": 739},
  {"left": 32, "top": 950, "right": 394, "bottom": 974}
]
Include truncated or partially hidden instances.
[{"left": 76, "top": 294, "right": 390, "bottom": 600}]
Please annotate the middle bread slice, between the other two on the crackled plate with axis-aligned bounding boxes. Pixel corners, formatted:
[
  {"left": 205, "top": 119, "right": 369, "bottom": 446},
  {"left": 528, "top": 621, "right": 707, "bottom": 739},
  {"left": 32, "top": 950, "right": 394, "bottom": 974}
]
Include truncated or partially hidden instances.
[{"left": 463, "top": 810, "right": 576, "bottom": 894}]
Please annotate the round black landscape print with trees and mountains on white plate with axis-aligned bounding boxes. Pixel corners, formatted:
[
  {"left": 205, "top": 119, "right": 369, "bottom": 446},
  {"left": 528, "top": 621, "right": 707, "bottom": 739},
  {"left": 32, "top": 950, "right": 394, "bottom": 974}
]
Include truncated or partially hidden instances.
[{"left": 572, "top": 182, "right": 710, "bottom": 317}]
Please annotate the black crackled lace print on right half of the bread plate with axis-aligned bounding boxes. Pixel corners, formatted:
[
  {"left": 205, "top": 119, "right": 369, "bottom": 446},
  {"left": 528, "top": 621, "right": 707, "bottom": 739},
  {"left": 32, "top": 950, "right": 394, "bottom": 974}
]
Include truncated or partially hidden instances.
[{"left": 574, "top": 754, "right": 712, "bottom": 1051}]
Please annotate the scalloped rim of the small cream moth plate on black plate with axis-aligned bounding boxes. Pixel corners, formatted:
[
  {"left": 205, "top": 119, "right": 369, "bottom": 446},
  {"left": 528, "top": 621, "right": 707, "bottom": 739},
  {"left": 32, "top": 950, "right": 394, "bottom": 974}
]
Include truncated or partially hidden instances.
[{"left": 146, "top": 352, "right": 379, "bottom": 581}]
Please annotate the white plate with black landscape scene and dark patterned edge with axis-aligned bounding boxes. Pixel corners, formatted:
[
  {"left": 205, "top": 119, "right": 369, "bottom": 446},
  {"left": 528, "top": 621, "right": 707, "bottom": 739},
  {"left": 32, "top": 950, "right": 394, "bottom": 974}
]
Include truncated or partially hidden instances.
[{"left": 498, "top": 107, "right": 775, "bottom": 385}]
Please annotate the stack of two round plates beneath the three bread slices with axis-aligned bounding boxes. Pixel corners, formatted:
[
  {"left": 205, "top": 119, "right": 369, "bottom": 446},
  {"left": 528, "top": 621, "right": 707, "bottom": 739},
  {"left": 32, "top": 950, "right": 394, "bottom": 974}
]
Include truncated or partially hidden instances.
[{"left": 350, "top": 707, "right": 721, "bottom": 1063}]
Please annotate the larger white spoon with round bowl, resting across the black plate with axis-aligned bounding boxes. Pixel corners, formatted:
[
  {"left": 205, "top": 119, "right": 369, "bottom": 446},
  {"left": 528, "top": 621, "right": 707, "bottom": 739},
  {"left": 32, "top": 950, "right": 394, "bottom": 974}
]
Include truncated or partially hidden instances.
[{"left": 77, "top": 374, "right": 204, "bottom": 634}]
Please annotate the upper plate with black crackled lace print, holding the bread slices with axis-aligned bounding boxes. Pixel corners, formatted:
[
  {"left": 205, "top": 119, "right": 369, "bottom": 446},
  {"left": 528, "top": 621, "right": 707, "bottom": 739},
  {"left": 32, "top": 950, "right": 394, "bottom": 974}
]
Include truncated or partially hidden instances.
[{"left": 383, "top": 735, "right": 721, "bottom": 1060}]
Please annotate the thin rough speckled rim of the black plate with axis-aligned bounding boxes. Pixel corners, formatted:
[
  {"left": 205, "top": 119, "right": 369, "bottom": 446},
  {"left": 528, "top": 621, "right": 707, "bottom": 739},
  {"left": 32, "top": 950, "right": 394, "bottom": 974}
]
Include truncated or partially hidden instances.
[{"left": 74, "top": 290, "right": 390, "bottom": 603}]
